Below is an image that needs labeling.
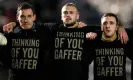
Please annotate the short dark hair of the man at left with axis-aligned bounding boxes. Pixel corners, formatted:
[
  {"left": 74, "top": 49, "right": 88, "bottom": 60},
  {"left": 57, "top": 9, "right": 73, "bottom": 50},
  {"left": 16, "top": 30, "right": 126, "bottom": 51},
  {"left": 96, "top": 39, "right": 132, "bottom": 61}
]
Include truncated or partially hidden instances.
[{"left": 17, "top": 2, "right": 35, "bottom": 14}]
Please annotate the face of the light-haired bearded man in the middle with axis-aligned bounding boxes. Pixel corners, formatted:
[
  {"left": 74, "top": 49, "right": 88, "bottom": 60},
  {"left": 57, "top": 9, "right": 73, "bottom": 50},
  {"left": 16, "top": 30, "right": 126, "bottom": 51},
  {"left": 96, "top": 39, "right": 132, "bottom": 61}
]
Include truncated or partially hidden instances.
[{"left": 61, "top": 6, "right": 79, "bottom": 24}]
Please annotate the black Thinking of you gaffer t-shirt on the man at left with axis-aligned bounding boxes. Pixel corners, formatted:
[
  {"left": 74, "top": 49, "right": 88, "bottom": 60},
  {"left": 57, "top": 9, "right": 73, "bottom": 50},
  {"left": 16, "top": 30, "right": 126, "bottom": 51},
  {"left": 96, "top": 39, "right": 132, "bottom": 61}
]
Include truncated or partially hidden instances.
[{"left": 3, "top": 25, "right": 51, "bottom": 80}]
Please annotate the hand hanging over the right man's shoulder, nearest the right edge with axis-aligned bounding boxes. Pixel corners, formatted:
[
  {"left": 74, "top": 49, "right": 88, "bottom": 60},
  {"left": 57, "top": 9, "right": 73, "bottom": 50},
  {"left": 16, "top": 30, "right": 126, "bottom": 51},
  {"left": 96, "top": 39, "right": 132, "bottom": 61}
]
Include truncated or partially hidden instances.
[{"left": 118, "top": 28, "right": 129, "bottom": 44}]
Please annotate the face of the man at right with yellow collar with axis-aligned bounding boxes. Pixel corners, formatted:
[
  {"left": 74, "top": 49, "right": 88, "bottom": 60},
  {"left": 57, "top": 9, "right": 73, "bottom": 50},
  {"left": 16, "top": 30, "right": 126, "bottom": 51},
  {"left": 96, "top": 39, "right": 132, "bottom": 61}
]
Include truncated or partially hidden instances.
[{"left": 101, "top": 16, "right": 118, "bottom": 37}]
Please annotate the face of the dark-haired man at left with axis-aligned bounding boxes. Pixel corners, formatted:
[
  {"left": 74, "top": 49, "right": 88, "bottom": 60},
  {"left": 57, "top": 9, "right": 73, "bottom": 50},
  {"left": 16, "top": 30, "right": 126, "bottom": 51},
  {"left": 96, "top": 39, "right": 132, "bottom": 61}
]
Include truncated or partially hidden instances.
[{"left": 17, "top": 9, "right": 36, "bottom": 29}]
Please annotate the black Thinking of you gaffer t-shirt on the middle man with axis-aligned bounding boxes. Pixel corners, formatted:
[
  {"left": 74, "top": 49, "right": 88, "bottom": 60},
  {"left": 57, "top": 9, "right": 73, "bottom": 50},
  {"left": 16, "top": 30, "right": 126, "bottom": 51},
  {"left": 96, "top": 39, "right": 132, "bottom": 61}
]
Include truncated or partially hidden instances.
[{"left": 51, "top": 26, "right": 93, "bottom": 80}]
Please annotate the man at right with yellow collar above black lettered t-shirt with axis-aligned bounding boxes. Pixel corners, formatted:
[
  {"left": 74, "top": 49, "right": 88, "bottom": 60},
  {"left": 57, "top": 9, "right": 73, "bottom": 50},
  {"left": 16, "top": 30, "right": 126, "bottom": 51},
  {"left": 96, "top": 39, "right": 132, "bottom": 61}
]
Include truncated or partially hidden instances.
[{"left": 86, "top": 13, "right": 129, "bottom": 80}]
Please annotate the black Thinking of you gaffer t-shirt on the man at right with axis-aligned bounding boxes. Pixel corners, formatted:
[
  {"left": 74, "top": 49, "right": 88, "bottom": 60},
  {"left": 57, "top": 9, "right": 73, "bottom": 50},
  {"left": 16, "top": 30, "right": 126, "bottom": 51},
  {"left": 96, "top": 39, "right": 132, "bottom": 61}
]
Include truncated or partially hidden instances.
[{"left": 88, "top": 33, "right": 128, "bottom": 80}]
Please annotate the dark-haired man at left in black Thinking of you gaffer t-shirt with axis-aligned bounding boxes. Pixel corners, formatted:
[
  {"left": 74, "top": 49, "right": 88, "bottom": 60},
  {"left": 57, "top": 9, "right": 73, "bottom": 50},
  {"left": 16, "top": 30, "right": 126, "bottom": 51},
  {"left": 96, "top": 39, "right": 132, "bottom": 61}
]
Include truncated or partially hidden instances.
[{"left": 2, "top": 3, "right": 51, "bottom": 80}]
